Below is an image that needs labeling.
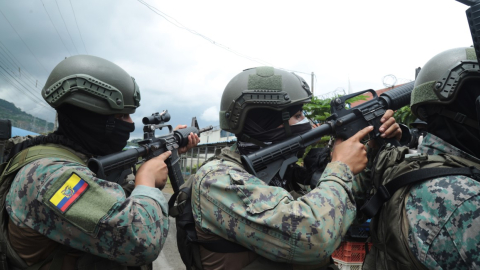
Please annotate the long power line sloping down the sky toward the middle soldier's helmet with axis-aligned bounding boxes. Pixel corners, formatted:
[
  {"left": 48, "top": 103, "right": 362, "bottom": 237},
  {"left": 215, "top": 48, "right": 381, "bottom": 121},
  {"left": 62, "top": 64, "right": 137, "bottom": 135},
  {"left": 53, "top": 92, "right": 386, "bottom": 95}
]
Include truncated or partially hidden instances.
[{"left": 138, "top": 0, "right": 310, "bottom": 75}]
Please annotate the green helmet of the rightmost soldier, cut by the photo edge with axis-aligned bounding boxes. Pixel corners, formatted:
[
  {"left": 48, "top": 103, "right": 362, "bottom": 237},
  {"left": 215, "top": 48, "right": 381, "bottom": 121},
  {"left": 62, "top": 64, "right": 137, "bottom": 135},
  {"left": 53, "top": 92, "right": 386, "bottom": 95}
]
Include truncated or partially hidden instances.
[{"left": 410, "top": 47, "right": 480, "bottom": 122}]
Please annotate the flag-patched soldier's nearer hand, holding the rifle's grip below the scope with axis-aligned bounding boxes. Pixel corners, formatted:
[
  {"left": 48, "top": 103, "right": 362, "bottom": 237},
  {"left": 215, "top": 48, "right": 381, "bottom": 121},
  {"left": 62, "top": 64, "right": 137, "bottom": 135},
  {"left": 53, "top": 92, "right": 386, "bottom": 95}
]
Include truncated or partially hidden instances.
[{"left": 135, "top": 151, "right": 172, "bottom": 189}]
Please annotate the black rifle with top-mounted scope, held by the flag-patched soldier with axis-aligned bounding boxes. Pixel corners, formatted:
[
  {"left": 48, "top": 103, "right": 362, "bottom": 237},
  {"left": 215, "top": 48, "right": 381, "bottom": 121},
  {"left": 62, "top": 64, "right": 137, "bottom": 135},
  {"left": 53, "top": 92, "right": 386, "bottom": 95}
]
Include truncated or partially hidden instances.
[{"left": 87, "top": 110, "right": 213, "bottom": 192}]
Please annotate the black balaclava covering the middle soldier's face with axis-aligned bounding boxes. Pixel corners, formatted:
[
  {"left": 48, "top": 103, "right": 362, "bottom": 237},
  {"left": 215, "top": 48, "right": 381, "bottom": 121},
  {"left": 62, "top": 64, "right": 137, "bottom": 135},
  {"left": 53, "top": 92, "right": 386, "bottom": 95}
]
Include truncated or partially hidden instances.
[{"left": 238, "top": 105, "right": 312, "bottom": 155}]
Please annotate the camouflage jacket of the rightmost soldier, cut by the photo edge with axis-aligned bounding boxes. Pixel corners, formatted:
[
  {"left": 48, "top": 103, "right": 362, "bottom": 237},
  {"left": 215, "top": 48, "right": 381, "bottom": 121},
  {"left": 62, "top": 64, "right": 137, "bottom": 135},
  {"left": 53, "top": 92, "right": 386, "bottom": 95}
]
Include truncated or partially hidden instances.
[{"left": 406, "top": 134, "right": 480, "bottom": 269}]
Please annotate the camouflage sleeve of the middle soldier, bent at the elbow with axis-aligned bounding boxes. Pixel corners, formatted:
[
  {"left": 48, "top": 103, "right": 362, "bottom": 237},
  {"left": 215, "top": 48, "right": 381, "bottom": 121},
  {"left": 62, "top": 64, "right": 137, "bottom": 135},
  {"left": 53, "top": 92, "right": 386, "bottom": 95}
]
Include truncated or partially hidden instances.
[{"left": 192, "top": 161, "right": 356, "bottom": 264}]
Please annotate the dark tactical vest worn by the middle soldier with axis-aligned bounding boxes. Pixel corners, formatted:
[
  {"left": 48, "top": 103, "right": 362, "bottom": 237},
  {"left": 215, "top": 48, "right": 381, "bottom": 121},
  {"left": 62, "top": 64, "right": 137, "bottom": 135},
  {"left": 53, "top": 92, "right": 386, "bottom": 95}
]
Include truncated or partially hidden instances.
[{"left": 168, "top": 147, "right": 338, "bottom": 270}]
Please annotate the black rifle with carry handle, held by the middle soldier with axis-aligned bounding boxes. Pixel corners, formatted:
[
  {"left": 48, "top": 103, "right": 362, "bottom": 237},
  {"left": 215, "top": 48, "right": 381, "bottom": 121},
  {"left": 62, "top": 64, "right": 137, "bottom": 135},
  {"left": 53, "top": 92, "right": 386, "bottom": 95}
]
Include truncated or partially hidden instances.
[{"left": 241, "top": 82, "right": 414, "bottom": 184}]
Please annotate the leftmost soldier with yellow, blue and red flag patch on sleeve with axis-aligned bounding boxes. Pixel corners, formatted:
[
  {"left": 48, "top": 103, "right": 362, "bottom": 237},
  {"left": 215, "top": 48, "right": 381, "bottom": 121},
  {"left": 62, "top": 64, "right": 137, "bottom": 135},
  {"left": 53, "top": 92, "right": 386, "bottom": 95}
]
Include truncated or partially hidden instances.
[{"left": 0, "top": 55, "right": 199, "bottom": 269}]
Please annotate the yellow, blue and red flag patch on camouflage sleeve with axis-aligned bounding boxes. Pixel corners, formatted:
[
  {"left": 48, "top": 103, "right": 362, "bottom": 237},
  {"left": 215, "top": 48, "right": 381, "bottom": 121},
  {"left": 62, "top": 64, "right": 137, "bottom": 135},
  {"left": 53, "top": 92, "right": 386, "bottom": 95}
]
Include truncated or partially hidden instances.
[{"left": 50, "top": 173, "right": 88, "bottom": 213}]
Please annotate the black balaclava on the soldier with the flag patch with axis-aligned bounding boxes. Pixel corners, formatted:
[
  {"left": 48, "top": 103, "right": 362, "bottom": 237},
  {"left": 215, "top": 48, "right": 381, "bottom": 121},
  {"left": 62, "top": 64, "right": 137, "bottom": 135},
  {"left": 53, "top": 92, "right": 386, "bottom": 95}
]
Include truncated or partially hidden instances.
[{"left": 55, "top": 105, "right": 135, "bottom": 156}]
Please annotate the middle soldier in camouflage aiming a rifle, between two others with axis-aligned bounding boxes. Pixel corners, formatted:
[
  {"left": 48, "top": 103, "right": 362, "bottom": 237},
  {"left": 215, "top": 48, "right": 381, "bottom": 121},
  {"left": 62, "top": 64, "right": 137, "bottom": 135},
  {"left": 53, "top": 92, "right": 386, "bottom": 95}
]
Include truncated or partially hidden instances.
[{"left": 188, "top": 67, "right": 400, "bottom": 269}]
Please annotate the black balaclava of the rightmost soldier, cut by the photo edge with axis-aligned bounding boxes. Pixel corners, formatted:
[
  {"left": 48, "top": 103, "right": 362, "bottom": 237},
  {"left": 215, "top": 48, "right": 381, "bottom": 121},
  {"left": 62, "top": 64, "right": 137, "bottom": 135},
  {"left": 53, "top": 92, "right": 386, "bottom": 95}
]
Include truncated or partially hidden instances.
[{"left": 427, "top": 80, "right": 480, "bottom": 158}]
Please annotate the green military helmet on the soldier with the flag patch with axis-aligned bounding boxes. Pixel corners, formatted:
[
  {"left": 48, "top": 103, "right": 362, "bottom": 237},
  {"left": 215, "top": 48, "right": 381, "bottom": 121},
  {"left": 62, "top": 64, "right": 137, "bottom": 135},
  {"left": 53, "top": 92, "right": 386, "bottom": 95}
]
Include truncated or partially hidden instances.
[{"left": 42, "top": 55, "right": 140, "bottom": 115}]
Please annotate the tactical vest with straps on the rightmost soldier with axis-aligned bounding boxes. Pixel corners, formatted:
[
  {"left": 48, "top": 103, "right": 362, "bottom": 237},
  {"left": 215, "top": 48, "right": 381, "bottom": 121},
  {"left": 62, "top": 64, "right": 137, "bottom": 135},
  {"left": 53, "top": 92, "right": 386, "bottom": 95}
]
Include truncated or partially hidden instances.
[{"left": 362, "top": 146, "right": 480, "bottom": 270}]
